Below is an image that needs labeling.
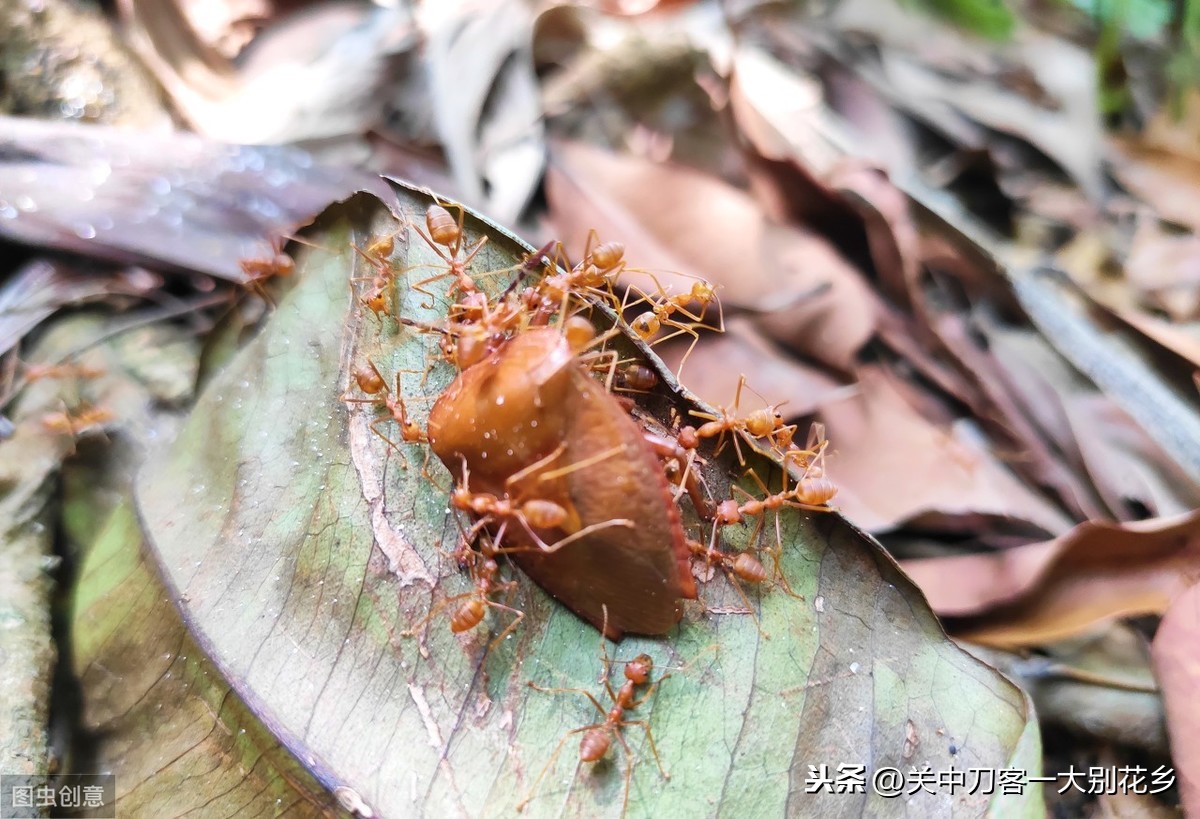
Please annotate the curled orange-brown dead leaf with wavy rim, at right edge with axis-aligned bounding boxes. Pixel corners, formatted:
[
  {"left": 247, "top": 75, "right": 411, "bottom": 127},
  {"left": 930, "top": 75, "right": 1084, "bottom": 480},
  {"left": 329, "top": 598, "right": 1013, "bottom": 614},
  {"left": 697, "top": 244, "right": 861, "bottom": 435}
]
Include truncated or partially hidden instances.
[{"left": 902, "top": 512, "right": 1200, "bottom": 647}]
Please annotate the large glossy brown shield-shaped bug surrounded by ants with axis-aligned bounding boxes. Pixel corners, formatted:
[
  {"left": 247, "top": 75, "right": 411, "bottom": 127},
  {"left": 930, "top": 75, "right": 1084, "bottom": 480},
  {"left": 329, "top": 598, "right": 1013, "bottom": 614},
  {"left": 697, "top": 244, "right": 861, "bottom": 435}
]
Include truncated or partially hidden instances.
[{"left": 428, "top": 327, "right": 696, "bottom": 639}]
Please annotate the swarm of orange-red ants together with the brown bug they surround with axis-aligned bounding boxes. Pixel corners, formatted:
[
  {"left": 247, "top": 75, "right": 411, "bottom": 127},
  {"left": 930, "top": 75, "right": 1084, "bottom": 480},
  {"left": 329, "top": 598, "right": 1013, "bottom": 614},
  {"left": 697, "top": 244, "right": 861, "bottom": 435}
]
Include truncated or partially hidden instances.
[{"left": 328, "top": 198, "right": 836, "bottom": 807}]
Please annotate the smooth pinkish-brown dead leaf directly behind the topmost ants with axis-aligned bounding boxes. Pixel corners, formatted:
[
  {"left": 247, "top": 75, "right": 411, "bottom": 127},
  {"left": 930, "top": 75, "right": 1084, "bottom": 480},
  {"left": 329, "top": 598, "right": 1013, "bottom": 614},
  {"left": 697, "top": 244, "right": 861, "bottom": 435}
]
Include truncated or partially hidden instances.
[{"left": 546, "top": 143, "right": 875, "bottom": 370}]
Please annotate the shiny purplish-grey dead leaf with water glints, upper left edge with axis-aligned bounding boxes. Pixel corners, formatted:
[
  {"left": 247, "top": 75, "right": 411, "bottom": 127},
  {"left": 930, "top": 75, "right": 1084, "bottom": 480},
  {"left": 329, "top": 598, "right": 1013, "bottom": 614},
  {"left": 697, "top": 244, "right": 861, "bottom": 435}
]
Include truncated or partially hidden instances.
[{"left": 0, "top": 116, "right": 385, "bottom": 282}]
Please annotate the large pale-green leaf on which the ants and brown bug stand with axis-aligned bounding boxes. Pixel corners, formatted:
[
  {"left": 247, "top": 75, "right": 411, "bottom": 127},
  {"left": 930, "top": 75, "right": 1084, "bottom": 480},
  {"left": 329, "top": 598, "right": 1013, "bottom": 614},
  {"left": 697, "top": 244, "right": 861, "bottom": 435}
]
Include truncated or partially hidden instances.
[{"left": 138, "top": 190, "right": 1042, "bottom": 817}]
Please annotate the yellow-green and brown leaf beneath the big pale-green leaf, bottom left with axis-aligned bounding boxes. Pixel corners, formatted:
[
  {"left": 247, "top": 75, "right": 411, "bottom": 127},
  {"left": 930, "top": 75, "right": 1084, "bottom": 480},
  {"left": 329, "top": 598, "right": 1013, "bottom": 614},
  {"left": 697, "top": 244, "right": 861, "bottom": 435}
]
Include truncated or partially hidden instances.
[{"left": 73, "top": 498, "right": 344, "bottom": 817}]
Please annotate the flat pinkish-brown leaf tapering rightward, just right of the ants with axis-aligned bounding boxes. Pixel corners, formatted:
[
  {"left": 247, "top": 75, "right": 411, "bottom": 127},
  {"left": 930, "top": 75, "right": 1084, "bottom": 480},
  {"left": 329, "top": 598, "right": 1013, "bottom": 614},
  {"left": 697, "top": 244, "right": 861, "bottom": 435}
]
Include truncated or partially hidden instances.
[{"left": 821, "top": 366, "right": 1070, "bottom": 534}]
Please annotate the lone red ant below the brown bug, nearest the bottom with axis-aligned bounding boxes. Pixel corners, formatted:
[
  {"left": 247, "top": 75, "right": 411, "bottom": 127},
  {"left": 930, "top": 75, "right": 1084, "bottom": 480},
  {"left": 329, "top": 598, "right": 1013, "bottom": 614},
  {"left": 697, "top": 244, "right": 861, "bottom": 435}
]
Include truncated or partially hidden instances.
[{"left": 517, "top": 605, "right": 671, "bottom": 815}]
